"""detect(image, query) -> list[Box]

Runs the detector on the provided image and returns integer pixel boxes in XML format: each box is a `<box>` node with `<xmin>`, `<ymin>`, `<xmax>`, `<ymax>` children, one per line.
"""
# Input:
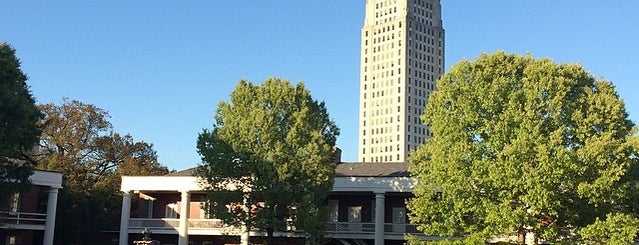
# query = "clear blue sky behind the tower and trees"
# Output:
<box><xmin>0</xmin><ymin>0</ymin><xmax>639</xmax><ymax>170</ymax></box>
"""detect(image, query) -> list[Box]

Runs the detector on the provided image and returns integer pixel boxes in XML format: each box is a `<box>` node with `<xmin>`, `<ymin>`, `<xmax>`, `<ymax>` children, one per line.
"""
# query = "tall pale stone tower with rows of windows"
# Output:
<box><xmin>358</xmin><ymin>0</ymin><xmax>444</xmax><ymax>162</ymax></box>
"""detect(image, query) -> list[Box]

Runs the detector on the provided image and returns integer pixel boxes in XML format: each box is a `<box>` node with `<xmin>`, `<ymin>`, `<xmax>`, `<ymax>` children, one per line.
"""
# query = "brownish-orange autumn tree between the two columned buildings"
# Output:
<box><xmin>29</xmin><ymin>99</ymin><xmax>168</xmax><ymax>244</ymax></box>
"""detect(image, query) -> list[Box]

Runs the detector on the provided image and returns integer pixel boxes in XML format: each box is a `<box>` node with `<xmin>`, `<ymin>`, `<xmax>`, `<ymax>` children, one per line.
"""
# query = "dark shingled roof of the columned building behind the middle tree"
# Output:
<box><xmin>166</xmin><ymin>162</ymin><xmax>409</xmax><ymax>177</ymax></box>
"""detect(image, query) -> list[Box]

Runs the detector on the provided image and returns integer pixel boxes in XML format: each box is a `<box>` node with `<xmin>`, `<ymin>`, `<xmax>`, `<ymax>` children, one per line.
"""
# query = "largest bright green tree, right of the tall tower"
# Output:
<box><xmin>408</xmin><ymin>52</ymin><xmax>639</xmax><ymax>244</ymax></box>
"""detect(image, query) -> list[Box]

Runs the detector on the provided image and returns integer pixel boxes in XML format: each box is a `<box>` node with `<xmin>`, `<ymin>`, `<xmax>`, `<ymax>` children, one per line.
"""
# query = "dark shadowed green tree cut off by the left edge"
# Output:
<box><xmin>0</xmin><ymin>43</ymin><xmax>41</xmax><ymax>211</ymax></box>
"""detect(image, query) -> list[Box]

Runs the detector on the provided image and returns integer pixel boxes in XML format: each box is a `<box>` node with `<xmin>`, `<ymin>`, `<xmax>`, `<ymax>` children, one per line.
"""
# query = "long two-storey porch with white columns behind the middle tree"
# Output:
<box><xmin>120</xmin><ymin>164</ymin><xmax>419</xmax><ymax>245</ymax></box>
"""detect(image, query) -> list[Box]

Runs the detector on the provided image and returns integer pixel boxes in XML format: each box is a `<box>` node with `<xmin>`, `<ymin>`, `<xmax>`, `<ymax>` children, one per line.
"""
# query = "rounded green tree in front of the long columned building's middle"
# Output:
<box><xmin>197</xmin><ymin>78</ymin><xmax>339</xmax><ymax>243</ymax></box>
